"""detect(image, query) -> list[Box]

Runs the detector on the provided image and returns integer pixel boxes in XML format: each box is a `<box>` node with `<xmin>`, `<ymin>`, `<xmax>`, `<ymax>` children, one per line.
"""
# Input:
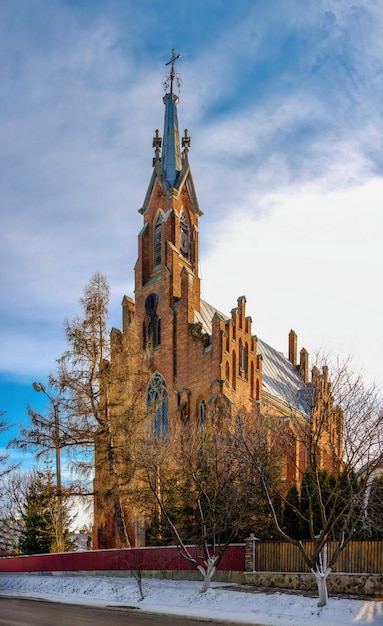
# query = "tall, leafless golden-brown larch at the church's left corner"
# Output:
<box><xmin>52</xmin><ymin>272</ymin><xmax>147</xmax><ymax>597</ymax></box>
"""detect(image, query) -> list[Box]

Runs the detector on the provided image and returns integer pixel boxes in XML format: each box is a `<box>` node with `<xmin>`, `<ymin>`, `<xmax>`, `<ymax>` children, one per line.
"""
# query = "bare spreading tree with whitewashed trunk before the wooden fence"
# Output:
<box><xmin>242</xmin><ymin>361</ymin><xmax>383</xmax><ymax>606</ymax></box>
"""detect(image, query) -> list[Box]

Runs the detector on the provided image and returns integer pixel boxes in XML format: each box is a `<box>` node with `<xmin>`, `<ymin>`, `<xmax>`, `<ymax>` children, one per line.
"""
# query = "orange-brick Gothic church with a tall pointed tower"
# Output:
<box><xmin>93</xmin><ymin>51</ymin><xmax>342</xmax><ymax>548</ymax></box>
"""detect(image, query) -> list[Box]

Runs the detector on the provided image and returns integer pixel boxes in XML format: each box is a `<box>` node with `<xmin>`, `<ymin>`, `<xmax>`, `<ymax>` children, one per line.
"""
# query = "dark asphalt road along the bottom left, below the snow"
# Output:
<box><xmin>0</xmin><ymin>597</ymin><xmax>243</xmax><ymax>626</ymax></box>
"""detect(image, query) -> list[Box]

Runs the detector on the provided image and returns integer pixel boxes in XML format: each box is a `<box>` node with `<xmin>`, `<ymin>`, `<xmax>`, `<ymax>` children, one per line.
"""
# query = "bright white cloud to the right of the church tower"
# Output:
<box><xmin>202</xmin><ymin>173</ymin><xmax>383</xmax><ymax>384</ymax></box>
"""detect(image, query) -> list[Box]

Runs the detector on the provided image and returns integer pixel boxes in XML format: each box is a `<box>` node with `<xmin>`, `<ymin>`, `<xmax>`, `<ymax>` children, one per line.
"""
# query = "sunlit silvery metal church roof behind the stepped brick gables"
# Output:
<box><xmin>194</xmin><ymin>300</ymin><xmax>314</xmax><ymax>416</ymax></box>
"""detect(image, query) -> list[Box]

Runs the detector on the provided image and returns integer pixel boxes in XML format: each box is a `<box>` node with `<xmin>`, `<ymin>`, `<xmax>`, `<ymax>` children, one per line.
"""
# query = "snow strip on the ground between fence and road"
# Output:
<box><xmin>0</xmin><ymin>574</ymin><xmax>383</xmax><ymax>626</ymax></box>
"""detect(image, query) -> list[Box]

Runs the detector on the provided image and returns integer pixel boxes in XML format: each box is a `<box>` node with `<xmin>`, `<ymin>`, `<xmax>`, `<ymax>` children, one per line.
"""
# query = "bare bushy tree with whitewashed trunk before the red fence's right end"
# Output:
<box><xmin>136</xmin><ymin>415</ymin><xmax>270</xmax><ymax>592</ymax></box>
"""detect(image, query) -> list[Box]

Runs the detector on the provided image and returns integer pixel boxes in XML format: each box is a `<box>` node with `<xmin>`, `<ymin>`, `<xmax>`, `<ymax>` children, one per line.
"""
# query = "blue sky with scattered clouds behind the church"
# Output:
<box><xmin>0</xmin><ymin>0</ymin><xmax>383</xmax><ymax>468</ymax></box>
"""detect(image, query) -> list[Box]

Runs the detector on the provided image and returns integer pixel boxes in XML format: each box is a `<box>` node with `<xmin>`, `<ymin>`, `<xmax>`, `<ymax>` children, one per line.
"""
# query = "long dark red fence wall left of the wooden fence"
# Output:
<box><xmin>0</xmin><ymin>544</ymin><xmax>245</xmax><ymax>572</ymax></box>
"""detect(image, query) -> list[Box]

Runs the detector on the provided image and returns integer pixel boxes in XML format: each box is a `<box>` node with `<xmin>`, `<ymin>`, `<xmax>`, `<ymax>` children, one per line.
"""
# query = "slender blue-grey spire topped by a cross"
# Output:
<box><xmin>162</xmin><ymin>49</ymin><xmax>182</xmax><ymax>187</ymax></box>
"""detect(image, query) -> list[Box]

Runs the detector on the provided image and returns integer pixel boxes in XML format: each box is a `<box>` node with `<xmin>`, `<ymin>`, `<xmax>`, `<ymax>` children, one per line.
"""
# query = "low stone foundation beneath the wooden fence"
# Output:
<box><xmin>244</xmin><ymin>572</ymin><xmax>383</xmax><ymax>598</ymax></box>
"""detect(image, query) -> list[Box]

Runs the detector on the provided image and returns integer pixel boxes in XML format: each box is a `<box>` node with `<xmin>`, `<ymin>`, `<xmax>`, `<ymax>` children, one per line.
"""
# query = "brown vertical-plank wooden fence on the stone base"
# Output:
<box><xmin>252</xmin><ymin>540</ymin><xmax>383</xmax><ymax>574</ymax></box>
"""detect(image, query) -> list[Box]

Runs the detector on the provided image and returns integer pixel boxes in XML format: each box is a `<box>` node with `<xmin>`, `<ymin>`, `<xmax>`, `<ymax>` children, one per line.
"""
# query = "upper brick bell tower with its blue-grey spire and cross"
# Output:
<box><xmin>135</xmin><ymin>50</ymin><xmax>202</xmax><ymax>354</ymax></box>
